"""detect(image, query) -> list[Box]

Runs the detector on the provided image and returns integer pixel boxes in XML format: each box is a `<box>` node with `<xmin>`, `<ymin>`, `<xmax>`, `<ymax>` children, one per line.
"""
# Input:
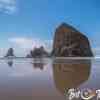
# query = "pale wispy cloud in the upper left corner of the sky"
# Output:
<box><xmin>0</xmin><ymin>0</ymin><xmax>17</xmax><ymax>14</ymax></box>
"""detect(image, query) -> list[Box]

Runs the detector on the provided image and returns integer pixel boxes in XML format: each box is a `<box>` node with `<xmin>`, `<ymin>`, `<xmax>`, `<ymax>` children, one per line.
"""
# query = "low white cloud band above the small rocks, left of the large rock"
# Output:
<box><xmin>8</xmin><ymin>37</ymin><xmax>52</xmax><ymax>49</ymax></box>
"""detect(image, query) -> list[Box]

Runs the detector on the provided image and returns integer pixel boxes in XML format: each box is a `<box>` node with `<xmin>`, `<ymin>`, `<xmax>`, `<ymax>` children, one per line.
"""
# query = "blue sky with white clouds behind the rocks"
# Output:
<box><xmin>0</xmin><ymin>0</ymin><xmax>100</xmax><ymax>56</ymax></box>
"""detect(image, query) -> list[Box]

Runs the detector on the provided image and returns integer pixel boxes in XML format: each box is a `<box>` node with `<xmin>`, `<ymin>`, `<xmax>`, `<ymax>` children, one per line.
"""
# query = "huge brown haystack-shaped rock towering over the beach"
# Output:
<box><xmin>52</xmin><ymin>23</ymin><xmax>93</xmax><ymax>57</ymax></box>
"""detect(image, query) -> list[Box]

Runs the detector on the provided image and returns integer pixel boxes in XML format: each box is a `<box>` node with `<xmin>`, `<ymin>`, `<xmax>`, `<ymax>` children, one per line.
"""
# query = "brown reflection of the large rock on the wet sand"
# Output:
<box><xmin>53</xmin><ymin>61</ymin><xmax>91</xmax><ymax>94</ymax></box>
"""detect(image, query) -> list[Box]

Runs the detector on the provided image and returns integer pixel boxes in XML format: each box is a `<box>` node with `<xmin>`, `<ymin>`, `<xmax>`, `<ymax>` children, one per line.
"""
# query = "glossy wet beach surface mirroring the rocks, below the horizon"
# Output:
<box><xmin>0</xmin><ymin>58</ymin><xmax>100</xmax><ymax>100</ymax></box>
